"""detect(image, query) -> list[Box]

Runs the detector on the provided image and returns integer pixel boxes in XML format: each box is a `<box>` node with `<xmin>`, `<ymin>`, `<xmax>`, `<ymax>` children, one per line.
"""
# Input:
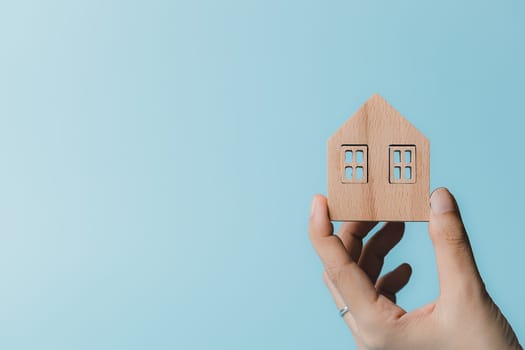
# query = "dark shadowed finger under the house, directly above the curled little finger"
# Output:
<box><xmin>359</xmin><ymin>222</ymin><xmax>405</xmax><ymax>284</ymax></box>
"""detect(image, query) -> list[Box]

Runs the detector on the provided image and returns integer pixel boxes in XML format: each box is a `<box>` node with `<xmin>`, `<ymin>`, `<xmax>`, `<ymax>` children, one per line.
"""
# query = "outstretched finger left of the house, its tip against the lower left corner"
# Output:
<box><xmin>310</xmin><ymin>195</ymin><xmax>377</xmax><ymax>317</ymax></box>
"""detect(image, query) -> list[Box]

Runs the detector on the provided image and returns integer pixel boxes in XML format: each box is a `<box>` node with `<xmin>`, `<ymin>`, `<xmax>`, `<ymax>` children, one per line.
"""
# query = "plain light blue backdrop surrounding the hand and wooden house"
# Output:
<box><xmin>0</xmin><ymin>0</ymin><xmax>525</xmax><ymax>349</ymax></box>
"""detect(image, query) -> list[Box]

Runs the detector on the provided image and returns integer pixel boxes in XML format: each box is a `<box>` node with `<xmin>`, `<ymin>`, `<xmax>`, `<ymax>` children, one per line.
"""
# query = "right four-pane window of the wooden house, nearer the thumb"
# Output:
<box><xmin>389</xmin><ymin>145</ymin><xmax>416</xmax><ymax>184</ymax></box>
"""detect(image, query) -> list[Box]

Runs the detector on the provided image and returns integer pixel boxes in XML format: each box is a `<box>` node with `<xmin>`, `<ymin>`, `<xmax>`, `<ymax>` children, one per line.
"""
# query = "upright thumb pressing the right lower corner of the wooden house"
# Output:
<box><xmin>429</xmin><ymin>188</ymin><xmax>483</xmax><ymax>296</ymax></box>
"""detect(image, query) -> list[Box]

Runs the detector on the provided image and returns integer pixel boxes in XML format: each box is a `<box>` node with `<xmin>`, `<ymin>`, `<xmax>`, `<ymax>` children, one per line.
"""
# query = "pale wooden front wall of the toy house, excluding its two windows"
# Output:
<box><xmin>328</xmin><ymin>95</ymin><xmax>430</xmax><ymax>221</ymax></box>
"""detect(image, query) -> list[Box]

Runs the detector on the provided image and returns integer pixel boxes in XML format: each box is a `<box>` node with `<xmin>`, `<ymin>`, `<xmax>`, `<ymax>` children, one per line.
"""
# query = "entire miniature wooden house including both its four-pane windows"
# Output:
<box><xmin>328</xmin><ymin>94</ymin><xmax>430</xmax><ymax>221</ymax></box>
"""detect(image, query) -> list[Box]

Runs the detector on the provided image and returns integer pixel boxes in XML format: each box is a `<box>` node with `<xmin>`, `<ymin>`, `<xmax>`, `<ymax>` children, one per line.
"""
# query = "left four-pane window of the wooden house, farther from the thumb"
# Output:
<box><xmin>341</xmin><ymin>145</ymin><xmax>368</xmax><ymax>183</ymax></box>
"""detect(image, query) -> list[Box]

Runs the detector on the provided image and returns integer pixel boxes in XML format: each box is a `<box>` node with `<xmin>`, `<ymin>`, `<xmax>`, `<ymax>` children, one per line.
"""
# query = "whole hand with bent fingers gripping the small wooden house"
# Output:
<box><xmin>309</xmin><ymin>188</ymin><xmax>522</xmax><ymax>350</ymax></box>
